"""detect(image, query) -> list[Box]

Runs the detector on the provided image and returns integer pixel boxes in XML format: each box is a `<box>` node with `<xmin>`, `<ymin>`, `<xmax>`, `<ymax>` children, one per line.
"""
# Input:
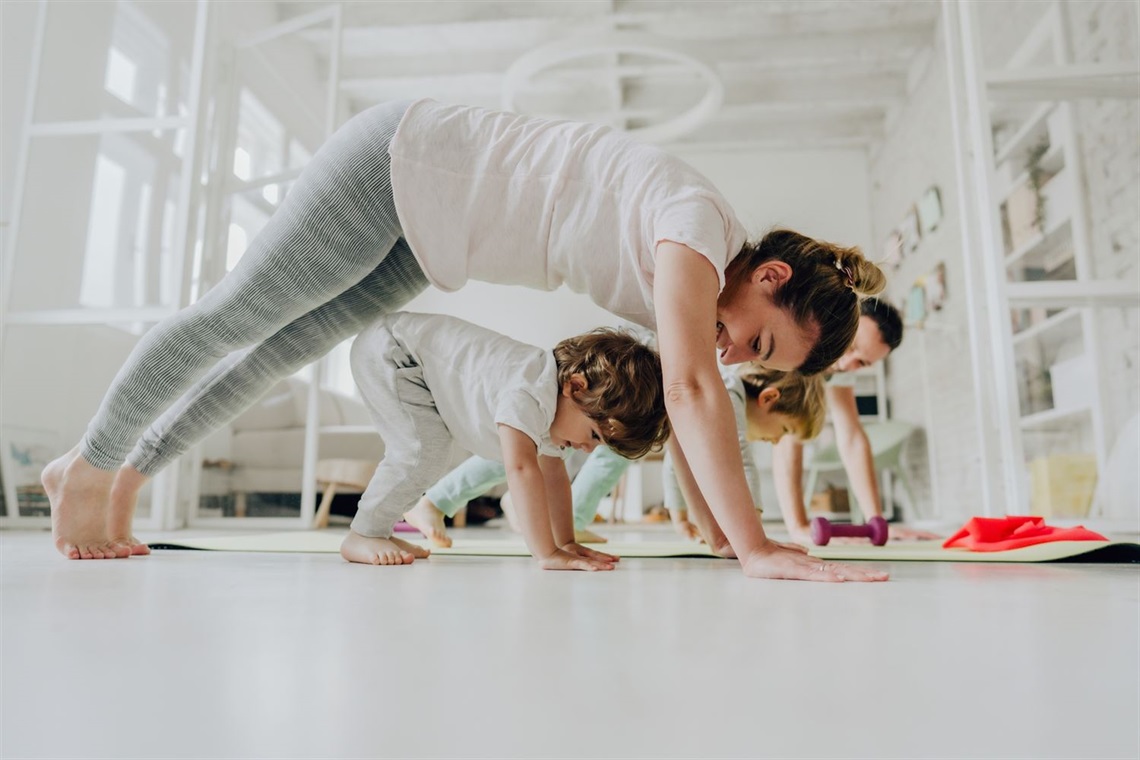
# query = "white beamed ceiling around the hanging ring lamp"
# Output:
<box><xmin>277</xmin><ymin>0</ymin><xmax>939</xmax><ymax>147</ymax></box>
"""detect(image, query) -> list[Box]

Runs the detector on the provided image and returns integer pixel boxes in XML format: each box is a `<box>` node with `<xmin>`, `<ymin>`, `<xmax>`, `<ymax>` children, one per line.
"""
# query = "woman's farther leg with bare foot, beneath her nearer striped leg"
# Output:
<box><xmin>107</xmin><ymin>238</ymin><xmax>428</xmax><ymax>554</ymax></box>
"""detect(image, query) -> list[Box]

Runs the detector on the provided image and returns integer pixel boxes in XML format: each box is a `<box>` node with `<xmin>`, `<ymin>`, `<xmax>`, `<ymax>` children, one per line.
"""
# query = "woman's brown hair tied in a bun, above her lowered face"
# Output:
<box><xmin>725</xmin><ymin>229</ymin><xmax>887</xmax><ymax>375</ymax></box>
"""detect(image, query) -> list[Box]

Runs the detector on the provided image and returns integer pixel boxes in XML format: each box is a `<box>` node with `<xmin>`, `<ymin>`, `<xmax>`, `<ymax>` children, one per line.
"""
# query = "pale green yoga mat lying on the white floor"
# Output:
<box><xmin>150</xmin><ymin>531</ymin><xmax>1140</xmax><ymax>563</ymax></box>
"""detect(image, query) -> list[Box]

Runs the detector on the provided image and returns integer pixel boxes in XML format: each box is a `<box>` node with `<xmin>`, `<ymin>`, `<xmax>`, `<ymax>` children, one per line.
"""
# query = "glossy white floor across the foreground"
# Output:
<box><xmin>0</xmin><ymin>528</ymin><xmax>1140</xmax><ymax>759</ymax></box>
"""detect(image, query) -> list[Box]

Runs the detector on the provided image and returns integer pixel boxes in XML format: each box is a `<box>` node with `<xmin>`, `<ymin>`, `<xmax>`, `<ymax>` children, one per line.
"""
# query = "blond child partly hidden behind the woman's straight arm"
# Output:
<box><xmin>661</xmin><ymin>365</ymin><xmax>824</xmax><ymax>538</ymax></box>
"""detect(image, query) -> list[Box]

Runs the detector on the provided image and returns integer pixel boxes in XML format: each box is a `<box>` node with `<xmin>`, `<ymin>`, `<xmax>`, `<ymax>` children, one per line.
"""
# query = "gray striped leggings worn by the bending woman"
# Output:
<box><xmin>81</xmin><ymin>103</ymin><xmax>428</xmax><ymax>475</ymax></box>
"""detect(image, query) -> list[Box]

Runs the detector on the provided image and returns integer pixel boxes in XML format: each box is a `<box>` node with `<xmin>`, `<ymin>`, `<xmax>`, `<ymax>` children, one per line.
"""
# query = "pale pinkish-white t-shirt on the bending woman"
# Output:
<box><xmin>389</xmin><ymin>100</ymin><xmax>747</xmax><ymax>329</ymax></box>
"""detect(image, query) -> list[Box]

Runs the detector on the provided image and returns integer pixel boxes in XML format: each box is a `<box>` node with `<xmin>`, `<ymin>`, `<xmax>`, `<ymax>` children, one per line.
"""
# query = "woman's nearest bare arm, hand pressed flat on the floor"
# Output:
<box><xmin>653</xmin><ymin>242</ymin><xmax>887</xmax><ymax>581</ymax></box>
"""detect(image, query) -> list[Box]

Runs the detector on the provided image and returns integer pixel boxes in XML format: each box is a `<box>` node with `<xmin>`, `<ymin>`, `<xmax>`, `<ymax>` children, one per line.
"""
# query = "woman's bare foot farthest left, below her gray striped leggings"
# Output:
<box><xmin>40</xmin><ymin>446</ymin><xmax>131</xmax><ymax>559</ymax></box>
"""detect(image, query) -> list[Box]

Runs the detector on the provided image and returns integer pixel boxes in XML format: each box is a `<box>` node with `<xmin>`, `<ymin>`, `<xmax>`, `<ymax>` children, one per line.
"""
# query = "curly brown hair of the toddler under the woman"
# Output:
<box><xmin>554</xmin><ymin>328</ymin><xmax>669</xmax><ymax>459</ymax></box>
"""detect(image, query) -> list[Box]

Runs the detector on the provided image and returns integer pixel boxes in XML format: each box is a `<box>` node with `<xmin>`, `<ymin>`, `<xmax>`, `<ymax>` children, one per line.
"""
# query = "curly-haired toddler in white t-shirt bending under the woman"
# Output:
<box><xmin>341</xmin><ymin>312</ymin><xmax>669</xmax><ymax>570</ymax></box>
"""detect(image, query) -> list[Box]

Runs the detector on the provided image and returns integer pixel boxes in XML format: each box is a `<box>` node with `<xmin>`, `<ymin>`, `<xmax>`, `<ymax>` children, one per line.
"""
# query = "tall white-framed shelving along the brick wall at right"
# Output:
<box><xmin>944</xmin><ymin>1</ymin><xmax>1140</xmax><ymax>516</ymax></box>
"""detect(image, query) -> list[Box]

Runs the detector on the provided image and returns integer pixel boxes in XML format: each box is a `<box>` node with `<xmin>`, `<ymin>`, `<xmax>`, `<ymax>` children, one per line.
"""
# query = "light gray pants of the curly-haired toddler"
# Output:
<box><xmin>351</xmin><ymin>324</ymin><xmax>451</xmax><ymax>538</ymax></box>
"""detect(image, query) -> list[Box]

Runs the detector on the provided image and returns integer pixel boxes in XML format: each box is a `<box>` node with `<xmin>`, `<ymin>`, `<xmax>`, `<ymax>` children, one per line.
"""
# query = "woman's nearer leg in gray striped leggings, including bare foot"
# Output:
<box><xmin>43</xmin><ymin>104</ymin><xmax>414</xmax><ymax>558</ymax></box>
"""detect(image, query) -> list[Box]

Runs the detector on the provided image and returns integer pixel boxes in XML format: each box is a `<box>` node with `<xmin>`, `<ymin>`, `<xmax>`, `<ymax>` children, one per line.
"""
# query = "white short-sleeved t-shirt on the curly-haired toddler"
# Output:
<box><xmin>381</xmin><ymin>311</ymin><xmax>564</xmax><ymax>461</ymax></box>
